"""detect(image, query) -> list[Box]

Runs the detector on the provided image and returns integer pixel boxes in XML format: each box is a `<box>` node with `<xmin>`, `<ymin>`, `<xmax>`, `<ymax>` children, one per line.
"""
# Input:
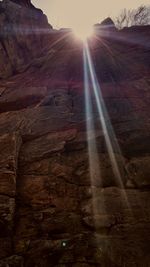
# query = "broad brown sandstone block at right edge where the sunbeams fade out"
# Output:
<box><xmin>83</xmin><ymin>187</ymin><xmax>149</xmax><ymax>228</ymax></box>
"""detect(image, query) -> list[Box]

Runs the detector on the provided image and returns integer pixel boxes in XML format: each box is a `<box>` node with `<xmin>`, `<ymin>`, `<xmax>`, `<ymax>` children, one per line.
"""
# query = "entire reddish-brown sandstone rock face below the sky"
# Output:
<box><xmin>0</xmin><ymin>0</ymin><xmax>150</xmax><ymax>267</ymax></box>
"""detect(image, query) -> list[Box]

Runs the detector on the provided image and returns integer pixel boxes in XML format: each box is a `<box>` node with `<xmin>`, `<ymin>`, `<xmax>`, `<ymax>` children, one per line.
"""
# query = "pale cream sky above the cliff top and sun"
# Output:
<box><xmin>32</xmin><ymin>0</ymin><xmax>149</xmax><ymax>29</ymax></box>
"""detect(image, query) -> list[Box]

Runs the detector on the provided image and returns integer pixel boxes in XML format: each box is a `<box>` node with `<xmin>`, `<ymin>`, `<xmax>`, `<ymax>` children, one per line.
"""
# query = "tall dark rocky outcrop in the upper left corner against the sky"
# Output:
<box><xmin>0</xmin><ymin>0</ymin><xmax>51</xmax><ymax>78</ymax></box>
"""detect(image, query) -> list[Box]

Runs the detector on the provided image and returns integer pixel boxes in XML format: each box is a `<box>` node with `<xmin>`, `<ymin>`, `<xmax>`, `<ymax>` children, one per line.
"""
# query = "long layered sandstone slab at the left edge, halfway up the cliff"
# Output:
<box><xmin>0</xmin><ymin>107</ymin><xmax>74</xmax><ymax>140</ymax></box>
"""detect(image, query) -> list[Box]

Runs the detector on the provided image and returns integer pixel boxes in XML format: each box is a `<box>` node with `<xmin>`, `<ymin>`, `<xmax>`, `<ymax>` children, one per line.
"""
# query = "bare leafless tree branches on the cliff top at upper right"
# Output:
<box><xmin>115</xmin><ymin>5</ymin><xmax>150</xmax><ymax>29</ymax></box>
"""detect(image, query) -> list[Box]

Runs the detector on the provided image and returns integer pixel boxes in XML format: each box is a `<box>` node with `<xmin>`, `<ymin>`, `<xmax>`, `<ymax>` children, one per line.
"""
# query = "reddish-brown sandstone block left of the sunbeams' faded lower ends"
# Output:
<box><xmin>18</xmin><ymin>175</ymin><xmax>78</xmax><ymax>210</ymax></box>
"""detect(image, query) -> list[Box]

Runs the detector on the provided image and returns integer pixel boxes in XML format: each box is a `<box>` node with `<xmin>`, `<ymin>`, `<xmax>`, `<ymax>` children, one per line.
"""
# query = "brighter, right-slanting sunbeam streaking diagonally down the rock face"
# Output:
<box><xmin>85</xmin><ymin>42</ymin><xmax>130</xmax><ymax>207</ymax></box>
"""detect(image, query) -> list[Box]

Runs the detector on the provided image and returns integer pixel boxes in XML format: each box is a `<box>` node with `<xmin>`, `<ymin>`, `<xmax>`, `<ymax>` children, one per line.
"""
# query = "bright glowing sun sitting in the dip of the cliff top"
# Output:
<box><xmin>72</xmin><ymin>25</ymin><xmax>94</xmax><ymax>42</ymax></box>
